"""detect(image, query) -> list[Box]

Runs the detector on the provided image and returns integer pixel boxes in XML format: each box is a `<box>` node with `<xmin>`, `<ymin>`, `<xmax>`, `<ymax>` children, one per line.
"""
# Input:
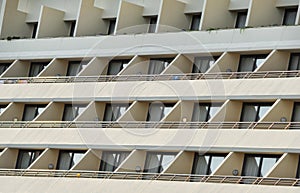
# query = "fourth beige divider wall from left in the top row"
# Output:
<box><xmin>116</xmin><ymin>1</ymin><xmax>148</xmax><ymax>34</ymax></box>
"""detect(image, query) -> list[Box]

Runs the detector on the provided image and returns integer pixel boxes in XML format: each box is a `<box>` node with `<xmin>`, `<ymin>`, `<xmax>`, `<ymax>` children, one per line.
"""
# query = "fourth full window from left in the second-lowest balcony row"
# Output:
<box><xmin>147</xmin><ymin>103</ymin><xmax>174</xmax><ymax>121</ymax></box>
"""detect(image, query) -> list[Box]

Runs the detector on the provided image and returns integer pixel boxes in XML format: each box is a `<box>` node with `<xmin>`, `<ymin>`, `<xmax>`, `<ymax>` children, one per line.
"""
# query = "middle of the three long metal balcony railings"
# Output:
<box><xmin>0</xmin><ymin>121</ymin><xmax>300</xmax><ymax>130</ymax></box>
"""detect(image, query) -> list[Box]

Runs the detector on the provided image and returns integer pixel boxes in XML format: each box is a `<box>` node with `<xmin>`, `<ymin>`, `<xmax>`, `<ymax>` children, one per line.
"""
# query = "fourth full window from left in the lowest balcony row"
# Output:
<box><xmin>144</xmin><ymin>152</ymin><xmax>176</xmax><ymax>173</ymax></box>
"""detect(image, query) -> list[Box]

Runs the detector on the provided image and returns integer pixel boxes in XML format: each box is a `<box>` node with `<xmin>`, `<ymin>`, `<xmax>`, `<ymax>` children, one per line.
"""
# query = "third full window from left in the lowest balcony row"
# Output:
<box><xmin>99</xmin><ymin>152</ymin><xmax>129</xmax><ymax>172</ymax></box>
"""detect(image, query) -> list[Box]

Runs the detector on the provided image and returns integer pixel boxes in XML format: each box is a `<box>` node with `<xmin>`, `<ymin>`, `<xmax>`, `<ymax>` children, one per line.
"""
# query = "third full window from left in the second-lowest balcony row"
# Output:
<box><xmin>103</xmin><ymin>103</ymin><xmax>130</xmax><ymax>121</ymax></box>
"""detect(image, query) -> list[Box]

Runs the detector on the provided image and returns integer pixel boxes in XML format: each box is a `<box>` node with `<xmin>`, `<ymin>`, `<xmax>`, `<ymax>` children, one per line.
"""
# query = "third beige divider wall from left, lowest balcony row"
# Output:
<box><xmin>71</xmin><ymin>149</ymin><xmax>102</xmax><ymax>171</ymax></box>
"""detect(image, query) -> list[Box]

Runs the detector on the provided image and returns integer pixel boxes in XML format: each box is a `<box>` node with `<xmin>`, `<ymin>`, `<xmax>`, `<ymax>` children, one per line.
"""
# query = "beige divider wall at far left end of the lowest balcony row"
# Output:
<box><xmin>0</xmin><ymin>148</ymin><xmax>19</xmax><ymax>169</ymax></box>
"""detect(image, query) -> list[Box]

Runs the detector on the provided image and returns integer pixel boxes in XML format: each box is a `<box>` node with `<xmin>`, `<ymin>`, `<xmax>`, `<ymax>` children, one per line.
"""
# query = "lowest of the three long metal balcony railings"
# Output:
<box><xmin>0</xmin><ymin>169</ymin><xmax>300</xmax><ymax>186</ymax></box>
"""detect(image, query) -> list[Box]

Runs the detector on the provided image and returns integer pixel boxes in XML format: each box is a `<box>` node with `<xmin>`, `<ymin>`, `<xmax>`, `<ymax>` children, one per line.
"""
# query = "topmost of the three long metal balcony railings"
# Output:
<box><xmin>0</xmin><ymin>71</ymin><xmax>300</xmax><ymax>84</ymax></box>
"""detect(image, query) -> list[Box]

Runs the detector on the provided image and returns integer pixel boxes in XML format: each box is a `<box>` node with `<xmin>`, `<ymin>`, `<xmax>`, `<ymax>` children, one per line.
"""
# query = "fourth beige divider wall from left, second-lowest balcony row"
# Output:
<box><xmin>118</xmin><ymin>101</ymin><xmax>149</xmax><ymax>121</ymax></box>
